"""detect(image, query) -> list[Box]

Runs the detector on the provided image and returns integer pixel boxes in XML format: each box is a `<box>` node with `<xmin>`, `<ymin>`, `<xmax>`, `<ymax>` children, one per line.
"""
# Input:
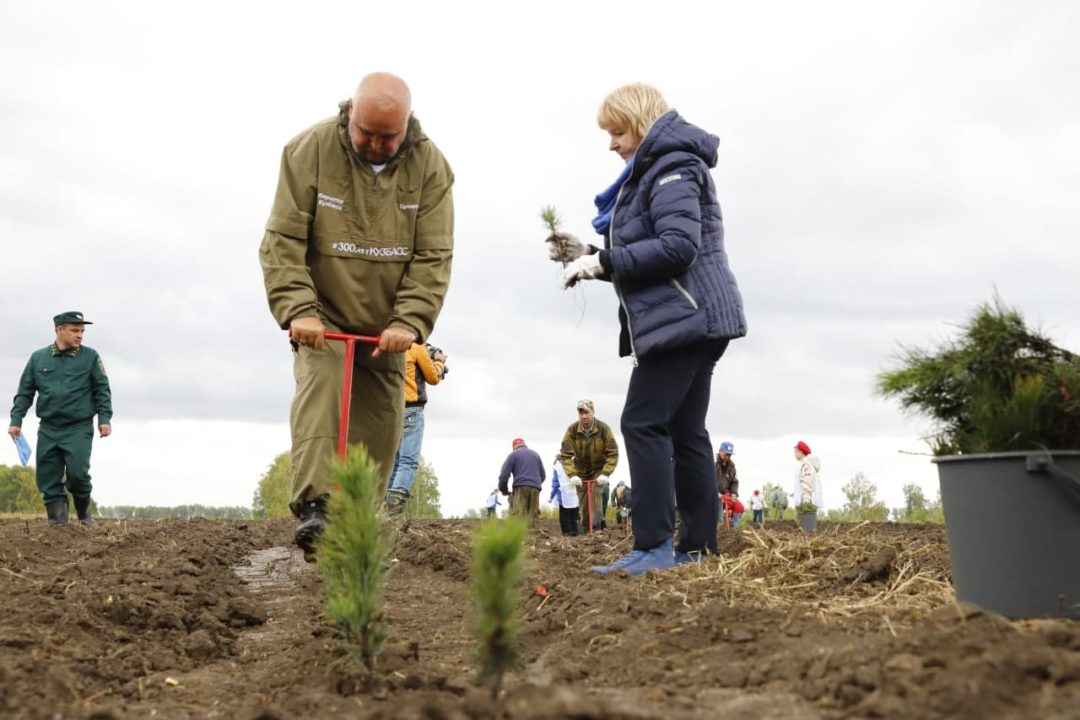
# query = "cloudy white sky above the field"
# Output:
<box><xmin>0</xmin><ymin>0</ymin><xmax>1080</xmax><ymax>514</ymax></box>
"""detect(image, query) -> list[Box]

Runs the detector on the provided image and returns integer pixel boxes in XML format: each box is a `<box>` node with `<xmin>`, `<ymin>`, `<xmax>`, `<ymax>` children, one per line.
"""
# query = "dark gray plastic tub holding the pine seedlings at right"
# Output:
<box><xmin>933</xmin><ymin>450</ymin><xmax>1080</xmax><ymax>620</ymax></box>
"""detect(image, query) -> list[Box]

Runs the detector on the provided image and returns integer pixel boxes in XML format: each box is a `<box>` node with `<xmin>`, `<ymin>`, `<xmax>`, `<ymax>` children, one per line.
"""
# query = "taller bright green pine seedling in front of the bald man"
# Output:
<box><xmin>315</xmin><ymin>447</ymin><xmax>389</xmax><ymax>680</ymax></box>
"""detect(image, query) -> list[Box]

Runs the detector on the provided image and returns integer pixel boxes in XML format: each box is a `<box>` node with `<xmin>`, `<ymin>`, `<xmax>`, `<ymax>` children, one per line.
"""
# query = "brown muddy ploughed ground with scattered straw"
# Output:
<box><xmin>0</xmin><ymin>519</ymin><xmax>1080</xmax><ymax>720</ymax></box>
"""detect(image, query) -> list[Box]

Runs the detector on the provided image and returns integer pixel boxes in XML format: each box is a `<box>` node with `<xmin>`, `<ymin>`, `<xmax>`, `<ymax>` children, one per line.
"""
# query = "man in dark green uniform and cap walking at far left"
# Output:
<box><xmin>8</xmin><ymin>311</ymin><xmax>112</xmax><ymax>526</ymax></box>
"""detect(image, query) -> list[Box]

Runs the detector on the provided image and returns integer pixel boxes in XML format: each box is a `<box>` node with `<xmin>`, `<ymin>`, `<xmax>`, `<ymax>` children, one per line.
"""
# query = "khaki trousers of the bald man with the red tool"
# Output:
<box><xmin>289</xmin><ymin>341</ymin><xmax>405</xmax><ymax>515</ymax></box>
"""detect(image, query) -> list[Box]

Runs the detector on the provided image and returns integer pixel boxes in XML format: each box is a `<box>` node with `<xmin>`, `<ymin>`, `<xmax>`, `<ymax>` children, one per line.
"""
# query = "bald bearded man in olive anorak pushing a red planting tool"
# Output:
<box><xmin>259</xmin><ymin>72</ymin><xmax>454</xmax><ymax>554</ymax></box>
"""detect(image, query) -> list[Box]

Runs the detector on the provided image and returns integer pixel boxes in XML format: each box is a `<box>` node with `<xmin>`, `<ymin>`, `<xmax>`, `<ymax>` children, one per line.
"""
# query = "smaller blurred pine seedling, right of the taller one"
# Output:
<box><xmin>472</xmin><ymin>518</ymin><xmax>527</xmax><ymax>699</ymax></box>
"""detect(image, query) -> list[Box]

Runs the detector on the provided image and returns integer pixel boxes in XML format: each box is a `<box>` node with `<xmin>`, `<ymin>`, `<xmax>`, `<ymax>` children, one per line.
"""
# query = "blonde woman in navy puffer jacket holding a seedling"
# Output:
<box><xmin>563</xmin><ymin>84</ymin><xmax>746</xmax><ymax>575</ymax></box>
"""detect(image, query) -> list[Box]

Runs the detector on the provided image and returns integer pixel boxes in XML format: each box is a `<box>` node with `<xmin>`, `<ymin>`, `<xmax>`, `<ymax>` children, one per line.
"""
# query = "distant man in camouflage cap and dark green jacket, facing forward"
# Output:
<box><xmin>559</xmin><ymin>400</ymin><xmax>619</xmax><ymax>532</ymax></box>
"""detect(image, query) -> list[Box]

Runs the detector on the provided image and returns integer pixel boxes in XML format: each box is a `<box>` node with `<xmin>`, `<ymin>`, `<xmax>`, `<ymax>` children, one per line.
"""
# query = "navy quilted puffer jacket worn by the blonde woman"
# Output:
<box><xmin>600</xmin><ymin>110</ymin><xmax>746</xmax><ymax>357</ymax></box>
